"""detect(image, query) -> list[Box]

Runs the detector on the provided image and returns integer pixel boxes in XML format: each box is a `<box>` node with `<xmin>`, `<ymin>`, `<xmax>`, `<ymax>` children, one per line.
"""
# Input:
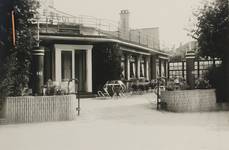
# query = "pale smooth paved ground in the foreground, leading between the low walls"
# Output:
<box><xmin>0</xmin><ymin>94</ymin><xmax>229</xmax><ymax>150</ymax></box>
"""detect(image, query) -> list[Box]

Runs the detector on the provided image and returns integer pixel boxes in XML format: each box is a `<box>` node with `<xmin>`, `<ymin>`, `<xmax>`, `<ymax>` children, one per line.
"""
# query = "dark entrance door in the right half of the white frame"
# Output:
<box><xmin>75</xmin><ymin>50</ymin><xmax>86</xmax><ymax>92</ymax></box>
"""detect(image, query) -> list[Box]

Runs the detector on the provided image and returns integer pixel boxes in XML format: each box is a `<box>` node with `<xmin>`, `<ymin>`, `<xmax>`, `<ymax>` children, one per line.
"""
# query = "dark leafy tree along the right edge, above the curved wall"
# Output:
<box><xmin>192</xmin><ymin>0</ymin><xmax>229</xmax><ymax>101</ymax></box>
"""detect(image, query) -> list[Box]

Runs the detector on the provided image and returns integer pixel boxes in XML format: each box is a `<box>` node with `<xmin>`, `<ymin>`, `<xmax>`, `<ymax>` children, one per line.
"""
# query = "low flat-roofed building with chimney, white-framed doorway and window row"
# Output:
<box><xmin>33</xmin><ymin>6</ymin><xmax>168</xmax><ymax>93</ymax></box>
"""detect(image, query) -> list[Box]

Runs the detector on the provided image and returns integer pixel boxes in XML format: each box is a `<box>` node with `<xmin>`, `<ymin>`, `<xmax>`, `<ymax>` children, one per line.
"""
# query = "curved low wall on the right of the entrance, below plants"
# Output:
<box><xmin>161</xmin><ymin>89</ymin><xmax>229</xmax><ymax>112</ymax></box>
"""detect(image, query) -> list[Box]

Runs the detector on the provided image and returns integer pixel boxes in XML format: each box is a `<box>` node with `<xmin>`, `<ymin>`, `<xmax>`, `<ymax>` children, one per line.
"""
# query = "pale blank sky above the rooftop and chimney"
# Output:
<box><xmin>44</xmin><ymin>0</ymin><xmax>212</xmax><ymax>48</ymax></box>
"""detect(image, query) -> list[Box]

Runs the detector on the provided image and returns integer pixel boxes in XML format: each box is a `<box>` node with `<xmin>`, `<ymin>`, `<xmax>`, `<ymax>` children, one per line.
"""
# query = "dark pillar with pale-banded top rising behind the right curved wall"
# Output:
<box><xmin>185</xmin><ymin>51</ymin><xmax>195</xmax><ymax>89</ymax></box>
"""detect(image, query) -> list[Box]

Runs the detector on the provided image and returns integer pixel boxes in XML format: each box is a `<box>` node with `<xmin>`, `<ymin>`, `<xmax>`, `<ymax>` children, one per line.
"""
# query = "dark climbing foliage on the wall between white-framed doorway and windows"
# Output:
<box><xmin>93</xmin><ymin>43</ymin><xmax>122</xmax><ymax>91</ymax></box>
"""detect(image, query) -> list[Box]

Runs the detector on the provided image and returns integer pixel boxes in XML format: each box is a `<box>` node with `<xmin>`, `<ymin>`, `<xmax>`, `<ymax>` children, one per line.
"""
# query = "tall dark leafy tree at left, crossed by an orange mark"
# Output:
<box><xmin>0</xmin><ymin>0</ymin><xmax>39</xmax><ymax>96</ymax></box>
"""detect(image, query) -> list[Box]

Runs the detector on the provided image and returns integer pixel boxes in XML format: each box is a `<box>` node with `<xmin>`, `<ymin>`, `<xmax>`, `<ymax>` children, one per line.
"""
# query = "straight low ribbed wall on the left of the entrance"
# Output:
<box><xmin>3</xmin><ymin>95</ymin><xmax>77</xmax><ymax>123</ymax></box>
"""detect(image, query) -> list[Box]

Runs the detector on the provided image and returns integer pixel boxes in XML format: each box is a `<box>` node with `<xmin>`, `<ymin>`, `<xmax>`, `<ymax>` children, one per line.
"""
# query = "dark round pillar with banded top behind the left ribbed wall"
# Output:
<box><xmin>32</xmin><ymin>47</ymin><xmax>44</xmax><ymax>95</ymax></box>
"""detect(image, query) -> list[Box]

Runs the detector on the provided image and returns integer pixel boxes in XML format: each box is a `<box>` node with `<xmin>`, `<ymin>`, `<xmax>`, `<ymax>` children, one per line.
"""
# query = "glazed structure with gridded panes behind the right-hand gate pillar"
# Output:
<box><xmin>168</xmin><ymin>41</ymin><xmax>222</xmax><ymax>83</ymax></box>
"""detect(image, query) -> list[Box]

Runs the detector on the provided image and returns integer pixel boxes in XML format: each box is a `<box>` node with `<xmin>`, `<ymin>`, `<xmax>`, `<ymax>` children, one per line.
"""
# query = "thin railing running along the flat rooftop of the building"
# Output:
<box><xmin>36</xmin><ymin>13</ymin><xmax>159</xmax><ymax>50</ymax></box>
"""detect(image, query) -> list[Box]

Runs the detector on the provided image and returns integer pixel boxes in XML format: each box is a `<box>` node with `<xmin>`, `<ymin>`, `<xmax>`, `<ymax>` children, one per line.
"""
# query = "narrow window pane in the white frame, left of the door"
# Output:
<box><xmin>61</xmin><ymin>51</ymin><xmax>72</xmax><ymax>80</ymax></box>
